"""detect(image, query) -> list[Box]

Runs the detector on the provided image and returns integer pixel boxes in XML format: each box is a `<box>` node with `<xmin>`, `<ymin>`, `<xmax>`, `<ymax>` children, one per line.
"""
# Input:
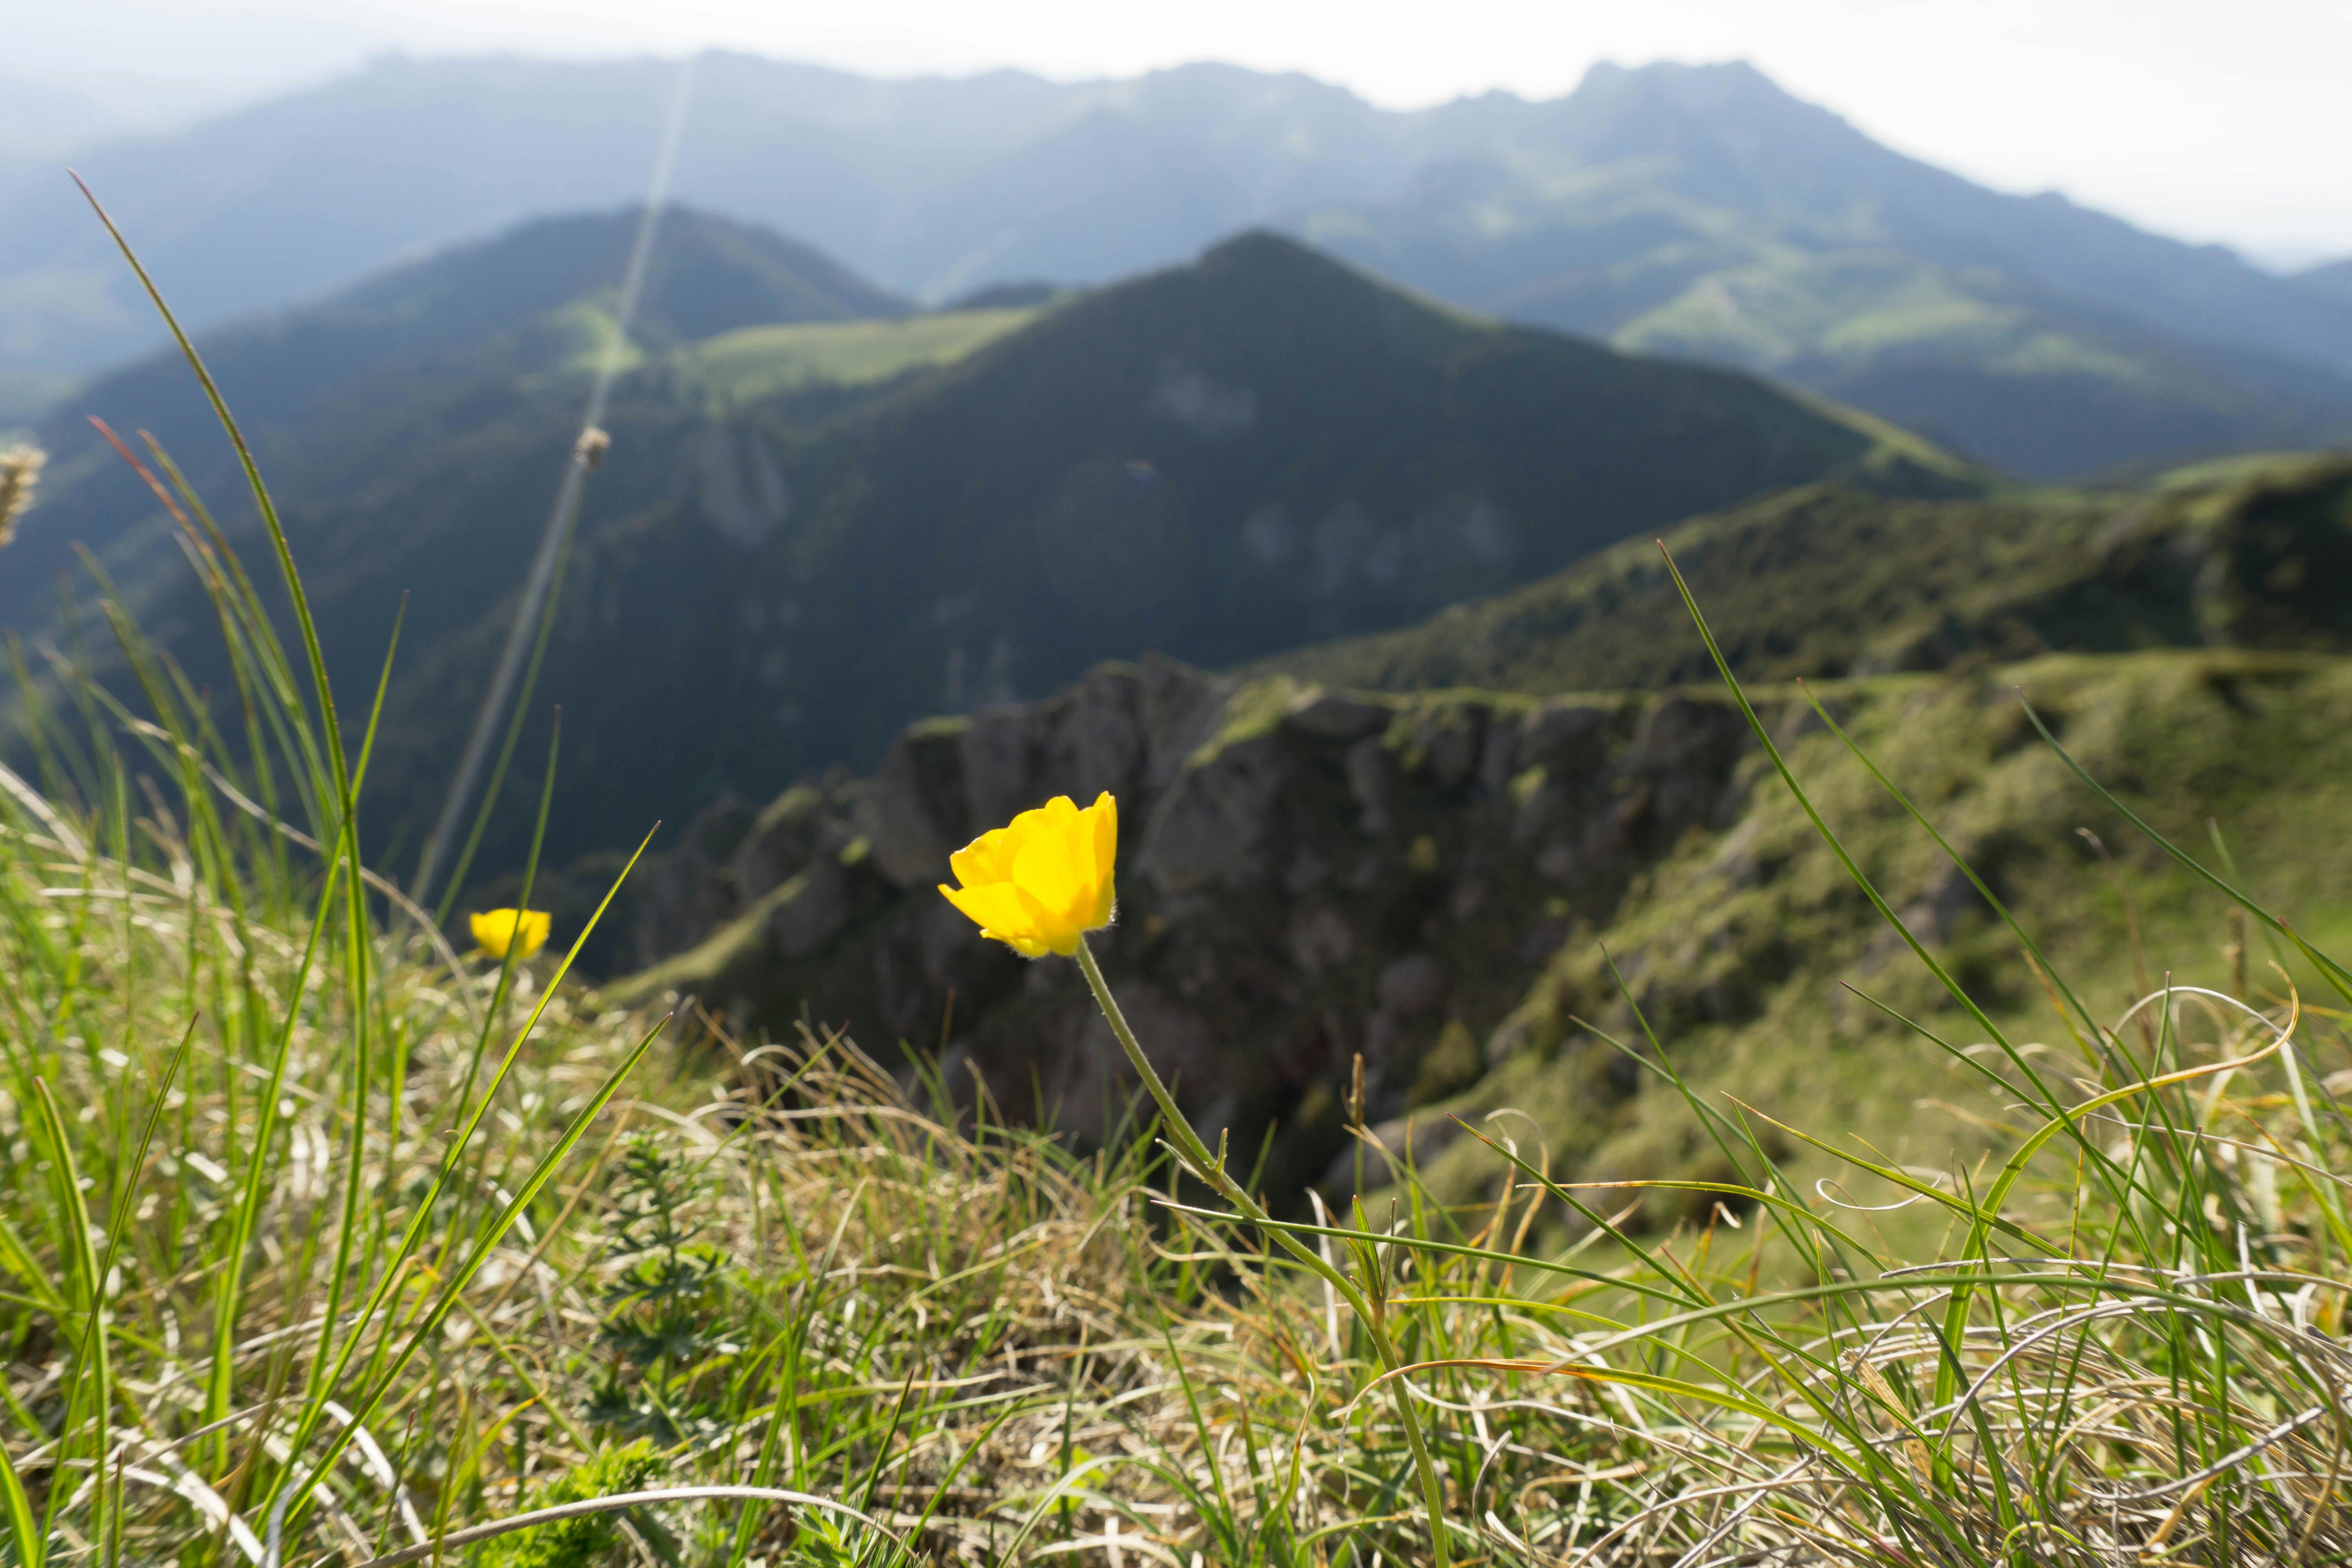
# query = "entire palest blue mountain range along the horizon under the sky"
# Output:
<box><xmin>14</xmin><ymin>54</ymin><xmax>2352</xmax><ymax>475</ymax></box>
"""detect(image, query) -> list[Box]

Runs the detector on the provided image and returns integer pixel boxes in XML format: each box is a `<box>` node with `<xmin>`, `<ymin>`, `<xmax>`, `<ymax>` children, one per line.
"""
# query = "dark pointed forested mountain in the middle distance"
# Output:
<box><xmin>358</xmin><ymin>235</ymin><xmax>1983</xmax><ymax>879</ymax></box>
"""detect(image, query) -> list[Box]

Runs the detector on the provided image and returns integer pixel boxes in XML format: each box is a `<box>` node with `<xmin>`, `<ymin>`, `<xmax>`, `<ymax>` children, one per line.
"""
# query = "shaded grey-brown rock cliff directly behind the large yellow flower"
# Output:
<box><xmin>614</xmin><ymin>663</ymin><xmax>1748</xmax><ymax>1189</ymax></box>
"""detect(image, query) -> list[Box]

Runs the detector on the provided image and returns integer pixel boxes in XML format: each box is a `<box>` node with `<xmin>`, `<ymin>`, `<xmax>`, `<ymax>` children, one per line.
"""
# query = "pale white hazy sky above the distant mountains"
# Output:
<box><xmin>14</xmin><ymin>0</ymin><xmax>2352</xmax><ymax>261</ymax></box>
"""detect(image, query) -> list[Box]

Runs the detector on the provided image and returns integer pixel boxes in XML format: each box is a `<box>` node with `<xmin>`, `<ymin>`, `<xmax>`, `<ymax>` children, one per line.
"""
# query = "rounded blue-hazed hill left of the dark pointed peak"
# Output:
<box><xmin>0</xmin><ymin>209</ymin><xmax>908</xmax><ymax>639</ymax></box>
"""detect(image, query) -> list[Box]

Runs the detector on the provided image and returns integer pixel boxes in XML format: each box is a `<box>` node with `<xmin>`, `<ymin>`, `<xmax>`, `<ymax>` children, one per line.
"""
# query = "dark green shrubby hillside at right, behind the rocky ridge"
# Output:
<box><xmin>1268</xmin><ymin>456</ymin><xmax>2352</xmax><ymax>691</ymax></box>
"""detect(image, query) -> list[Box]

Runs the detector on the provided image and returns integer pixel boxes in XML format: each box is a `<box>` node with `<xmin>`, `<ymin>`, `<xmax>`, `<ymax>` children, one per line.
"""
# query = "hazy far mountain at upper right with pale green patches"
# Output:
<box><xmin>1303</xmin><ymin>64</ymin><xmax>2352</xmax><ymax>477</ymax></box>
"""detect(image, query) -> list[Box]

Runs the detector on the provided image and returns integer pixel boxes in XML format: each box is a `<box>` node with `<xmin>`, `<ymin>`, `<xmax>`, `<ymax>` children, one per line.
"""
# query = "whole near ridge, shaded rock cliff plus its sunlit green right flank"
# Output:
<box><xmin>593</xmin><ymin>649</ymin><xmax>2352</xmax><ymax>1232</ymax></box>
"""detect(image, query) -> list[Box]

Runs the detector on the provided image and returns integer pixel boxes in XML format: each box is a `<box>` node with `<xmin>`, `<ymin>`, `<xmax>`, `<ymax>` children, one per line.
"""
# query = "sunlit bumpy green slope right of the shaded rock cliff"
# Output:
<box><xmin>1425</xmin><ymin>651</ymin><xmax>2352</xmax><ymax>1222</ymax></box>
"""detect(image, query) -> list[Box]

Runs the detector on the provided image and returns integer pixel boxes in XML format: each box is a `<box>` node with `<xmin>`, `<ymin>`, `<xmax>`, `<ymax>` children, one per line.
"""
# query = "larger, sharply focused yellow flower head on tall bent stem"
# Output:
<box><xmin>938</xmin><ymin>790</ymin><xmax>1120</xmax><ymax>959</ymax></box>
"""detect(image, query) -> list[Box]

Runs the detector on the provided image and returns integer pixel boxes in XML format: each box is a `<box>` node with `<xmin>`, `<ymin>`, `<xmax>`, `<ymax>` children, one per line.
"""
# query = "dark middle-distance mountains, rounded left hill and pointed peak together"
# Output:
<box><xmin>14</xmin><ymin>209</ymin><xmax>1983</xmax><ymax>865</ymax></box>
